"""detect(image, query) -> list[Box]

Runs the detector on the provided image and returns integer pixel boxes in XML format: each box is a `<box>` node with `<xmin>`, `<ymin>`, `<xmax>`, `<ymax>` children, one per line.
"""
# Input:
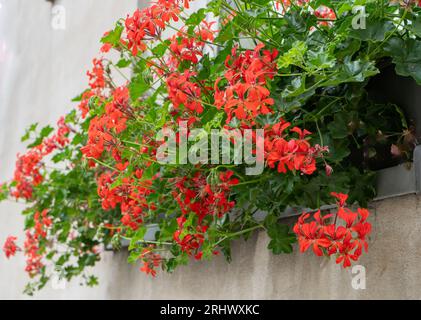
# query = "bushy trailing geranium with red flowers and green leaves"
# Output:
<box><xmin>0</xmin><ymin>0</ymin><xmax>421</xmax><ymax>294</ymax></box>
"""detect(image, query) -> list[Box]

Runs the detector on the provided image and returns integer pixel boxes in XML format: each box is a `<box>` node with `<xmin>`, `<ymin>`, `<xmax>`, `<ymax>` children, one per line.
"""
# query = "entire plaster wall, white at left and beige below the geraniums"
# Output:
<box><xmin>0</xmin><ymin>0</ymin><xmax>421</xmax><ymax>299</ymax></box>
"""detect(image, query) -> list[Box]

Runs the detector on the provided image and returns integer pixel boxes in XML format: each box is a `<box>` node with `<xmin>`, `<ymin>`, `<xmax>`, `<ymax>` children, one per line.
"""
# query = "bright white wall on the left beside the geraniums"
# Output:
<box><xmin>0</xmin><ymin>0</ymin><xmax>137</xmax><ymax>298</ymax></box>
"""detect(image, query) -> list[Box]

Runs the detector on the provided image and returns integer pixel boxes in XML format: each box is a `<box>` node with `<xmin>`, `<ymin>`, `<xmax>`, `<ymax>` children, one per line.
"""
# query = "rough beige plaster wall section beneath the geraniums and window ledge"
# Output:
<box><xmin>92</xmin><ymin>195</ymin><xmax>421</xmax><ymax>299</ymax></box>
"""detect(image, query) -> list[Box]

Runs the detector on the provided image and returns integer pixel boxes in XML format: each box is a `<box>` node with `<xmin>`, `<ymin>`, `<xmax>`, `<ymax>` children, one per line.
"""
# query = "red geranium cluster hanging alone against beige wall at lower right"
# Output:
<box><xmin>293</xmin><ymin>192</ymin><xmax>371</xmax><ymax>268</ymax></box>
